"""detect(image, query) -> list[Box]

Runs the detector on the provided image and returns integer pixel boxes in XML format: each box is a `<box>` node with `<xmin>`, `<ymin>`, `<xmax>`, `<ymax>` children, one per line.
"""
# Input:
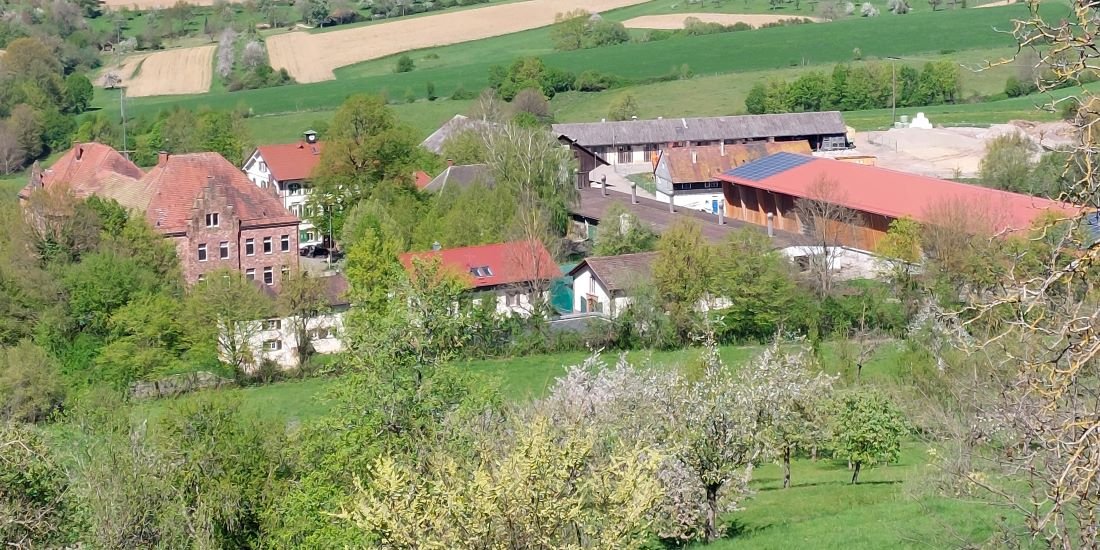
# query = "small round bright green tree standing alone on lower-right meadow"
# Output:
<box><xmin>833</xmin><ymin>391</ymin><xmax>909</xmax><ymax>484</ymax></box>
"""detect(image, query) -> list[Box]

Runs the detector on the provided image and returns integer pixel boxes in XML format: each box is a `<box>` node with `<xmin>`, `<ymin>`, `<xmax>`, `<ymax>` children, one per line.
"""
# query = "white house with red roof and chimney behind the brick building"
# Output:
<box><xmin>243</xmin><ymin>131</ymin><xmax>325</xmax><ymax>246</ymax></box>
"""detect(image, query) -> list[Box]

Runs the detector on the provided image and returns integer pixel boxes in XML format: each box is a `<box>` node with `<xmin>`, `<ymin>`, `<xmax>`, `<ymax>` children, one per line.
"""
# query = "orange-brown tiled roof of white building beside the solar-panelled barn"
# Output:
<box><xmin>659</xmin><ymin>140</ymin><xmax>813</xmax><ymax>184</ymax></box>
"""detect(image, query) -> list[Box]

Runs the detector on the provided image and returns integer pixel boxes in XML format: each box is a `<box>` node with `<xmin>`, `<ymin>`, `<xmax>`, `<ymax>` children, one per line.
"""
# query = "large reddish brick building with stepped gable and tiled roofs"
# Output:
<box><xmin>20</xmin><ymin>143</ymin><xmax>298</xmax><ymax>289</ymax></box>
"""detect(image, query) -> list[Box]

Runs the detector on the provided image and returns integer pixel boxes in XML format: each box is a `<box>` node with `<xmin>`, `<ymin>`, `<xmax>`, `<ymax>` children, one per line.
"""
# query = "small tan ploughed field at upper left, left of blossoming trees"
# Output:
<box><xmin>104</xmin><ymin>44</ymin><xmax>217</xmax><ymax>98</ymax></box>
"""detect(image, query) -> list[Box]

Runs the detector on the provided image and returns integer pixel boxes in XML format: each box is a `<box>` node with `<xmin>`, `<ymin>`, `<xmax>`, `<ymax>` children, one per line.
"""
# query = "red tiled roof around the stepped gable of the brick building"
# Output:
<box><xmin>142</xmin><ymin>153</ymin><xmax>298</xmax><ymax>233</ymax></box>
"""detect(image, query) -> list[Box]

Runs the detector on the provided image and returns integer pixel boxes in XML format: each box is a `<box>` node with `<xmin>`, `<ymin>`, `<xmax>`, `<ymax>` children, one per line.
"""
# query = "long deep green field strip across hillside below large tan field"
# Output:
<box><xmin>97</xmin><ymin>6</ymin><xmax>1062</xmax><ymax>122</ymax></box>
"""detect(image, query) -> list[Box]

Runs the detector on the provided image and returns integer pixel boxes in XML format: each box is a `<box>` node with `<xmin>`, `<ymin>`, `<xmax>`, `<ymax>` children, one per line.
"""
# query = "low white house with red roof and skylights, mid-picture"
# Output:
<box><xmin>398</xmin><ymin>241</ymin><xmax>561</xmax><ymax>315</ymax></box>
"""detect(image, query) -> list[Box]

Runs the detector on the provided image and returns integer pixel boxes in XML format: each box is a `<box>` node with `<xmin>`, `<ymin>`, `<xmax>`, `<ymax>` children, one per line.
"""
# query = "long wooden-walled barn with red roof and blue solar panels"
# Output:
<box><xmin>718</xmin><ymin>153</ymin><xmax>1077</xmax><ymax>251</ymax></box>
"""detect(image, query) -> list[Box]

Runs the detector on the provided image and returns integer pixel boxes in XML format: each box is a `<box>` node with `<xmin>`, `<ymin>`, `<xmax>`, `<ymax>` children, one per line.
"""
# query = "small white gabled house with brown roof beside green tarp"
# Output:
<box><xmin>569</xmin><ymin>252</ymin><xmax>657</xmax><ymax>318</ymax></box>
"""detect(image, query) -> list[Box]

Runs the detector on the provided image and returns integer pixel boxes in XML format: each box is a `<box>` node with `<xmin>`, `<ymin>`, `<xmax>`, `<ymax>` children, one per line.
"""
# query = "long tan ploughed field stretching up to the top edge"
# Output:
<box><xmin>267</xmin><ymin>0</ymin><xmax>646</xmax><ymax>83</ymax></box>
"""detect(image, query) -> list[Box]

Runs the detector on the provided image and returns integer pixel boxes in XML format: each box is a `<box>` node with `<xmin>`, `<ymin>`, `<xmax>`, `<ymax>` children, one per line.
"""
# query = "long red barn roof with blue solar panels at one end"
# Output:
<box><xmin>719</xmin><ymin>153</ymin><xmax>1078</xmax><ymax>232</ymax></box>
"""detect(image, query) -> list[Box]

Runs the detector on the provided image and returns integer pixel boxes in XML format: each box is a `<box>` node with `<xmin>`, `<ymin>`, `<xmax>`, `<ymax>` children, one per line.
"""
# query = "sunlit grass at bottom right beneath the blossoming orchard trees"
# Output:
<box><xmin>699</xmin><ymin>443</ymin><xmax>1001</xmax><ymax>550</ymax></box>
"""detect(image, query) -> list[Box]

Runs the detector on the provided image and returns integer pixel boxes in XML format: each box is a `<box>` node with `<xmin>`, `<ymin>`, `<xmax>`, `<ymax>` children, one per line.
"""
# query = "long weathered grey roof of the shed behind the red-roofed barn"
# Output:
<box><xmin>553</xmin><ymin>111</ymin><xmax>847</xmax><ymax>147</ymax></box>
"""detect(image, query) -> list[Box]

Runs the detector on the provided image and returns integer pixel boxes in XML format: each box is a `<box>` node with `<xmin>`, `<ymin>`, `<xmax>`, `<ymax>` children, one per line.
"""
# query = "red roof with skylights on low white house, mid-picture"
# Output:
<box><xmin>399</xmin><ymin>241</ymin><xmax>561</xmax><ymax>288</ymax></box>
